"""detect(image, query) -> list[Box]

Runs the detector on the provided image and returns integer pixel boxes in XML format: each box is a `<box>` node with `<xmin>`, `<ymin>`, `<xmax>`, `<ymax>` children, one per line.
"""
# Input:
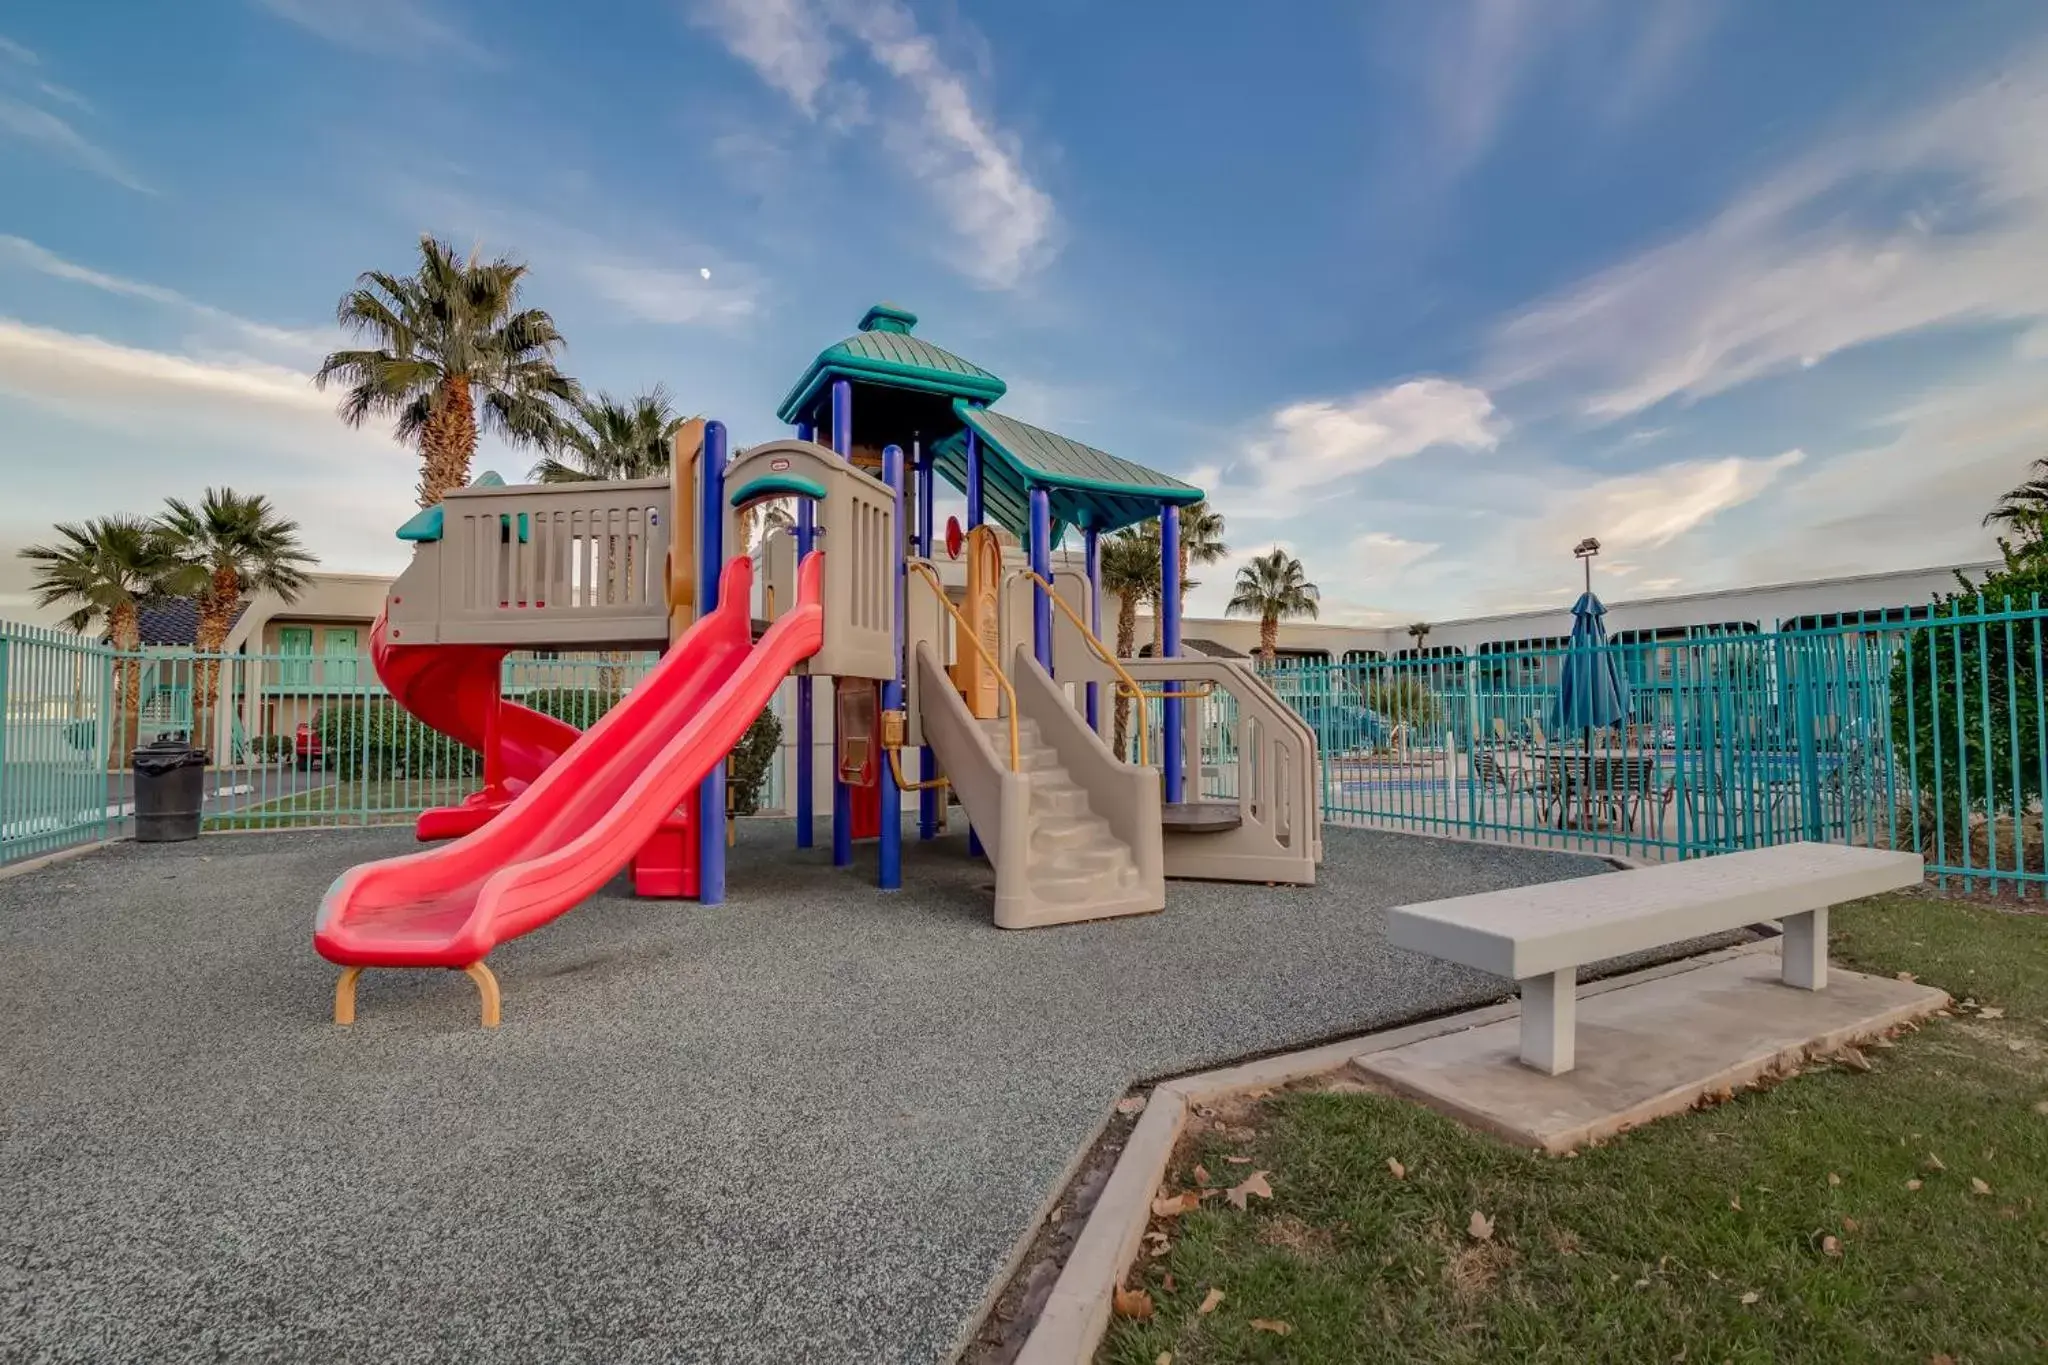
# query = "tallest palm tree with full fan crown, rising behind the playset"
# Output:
<box><xmin>313</xmin><ymin>237</ymin><xmax>582</xmax><ymax>508</ymax></box>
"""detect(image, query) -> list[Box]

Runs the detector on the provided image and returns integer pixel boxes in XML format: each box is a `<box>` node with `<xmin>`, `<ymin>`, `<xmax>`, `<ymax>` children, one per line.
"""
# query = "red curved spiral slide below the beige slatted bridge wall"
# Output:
<box><xmin>371</xmin><ymin>616</ymin><xmax>582</xmax><ymax>839</ymax></box>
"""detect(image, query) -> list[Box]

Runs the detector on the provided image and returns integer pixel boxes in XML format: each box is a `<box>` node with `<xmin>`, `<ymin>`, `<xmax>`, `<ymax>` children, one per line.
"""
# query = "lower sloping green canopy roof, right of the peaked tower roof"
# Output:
<box><xmin>932</xmin><ymin>401</ymin><xmax>1202</xmax><ymax>544</ymax></box>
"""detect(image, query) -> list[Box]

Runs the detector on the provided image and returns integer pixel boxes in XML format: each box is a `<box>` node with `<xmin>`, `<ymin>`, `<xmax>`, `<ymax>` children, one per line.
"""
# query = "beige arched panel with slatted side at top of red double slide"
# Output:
<box><xmin>725</xmin><ymin>440</ymin><xmax>901</xmax><ymax>677</ymax></box>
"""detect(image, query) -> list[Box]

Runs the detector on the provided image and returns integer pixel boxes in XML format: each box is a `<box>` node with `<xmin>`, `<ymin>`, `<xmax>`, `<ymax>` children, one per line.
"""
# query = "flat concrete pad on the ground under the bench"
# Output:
<box><xmin>1354</xmin><ymin>954</ymin><xmax>1948</xmax><ymax>1152</ymax></box>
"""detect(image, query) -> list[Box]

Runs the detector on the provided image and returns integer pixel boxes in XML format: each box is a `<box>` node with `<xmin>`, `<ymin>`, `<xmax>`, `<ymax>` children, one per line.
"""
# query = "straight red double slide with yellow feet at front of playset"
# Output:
<box><xmin>313</xmin><ymin>553</ymin><xmax>825</xmax><ymax>968</ymax></box>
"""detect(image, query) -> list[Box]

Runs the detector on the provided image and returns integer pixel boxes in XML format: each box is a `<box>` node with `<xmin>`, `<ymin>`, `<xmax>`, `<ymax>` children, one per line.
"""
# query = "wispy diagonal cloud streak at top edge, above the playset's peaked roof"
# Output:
<box><xmin>696</xmin><ymin>0</ymin><xmax>1059</xmax><ymax>289</ymax></box>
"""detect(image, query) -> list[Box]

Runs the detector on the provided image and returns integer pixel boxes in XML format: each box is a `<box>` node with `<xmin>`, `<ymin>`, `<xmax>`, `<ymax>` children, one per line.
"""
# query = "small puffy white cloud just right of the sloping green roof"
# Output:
<box><xmin>1229</xmin><ymin>379</ymin><xmax>1505</xmax><ymax>508</ymax></box>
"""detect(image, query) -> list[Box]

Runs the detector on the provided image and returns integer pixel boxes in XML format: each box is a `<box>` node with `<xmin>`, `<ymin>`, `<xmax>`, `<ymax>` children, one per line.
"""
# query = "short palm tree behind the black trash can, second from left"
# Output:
<box><xmin>160</xmin><ymin>489</ymin><xmax>315</xmax><ymax>757</ymax></box>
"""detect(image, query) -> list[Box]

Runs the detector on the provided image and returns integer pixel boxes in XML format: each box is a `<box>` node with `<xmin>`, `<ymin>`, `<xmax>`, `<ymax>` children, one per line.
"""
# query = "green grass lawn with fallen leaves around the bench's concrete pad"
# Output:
<box><xmin>1098</xmin><ymin>896</ymin><xmax>2048</xmax><ymax>1365</ymax></box>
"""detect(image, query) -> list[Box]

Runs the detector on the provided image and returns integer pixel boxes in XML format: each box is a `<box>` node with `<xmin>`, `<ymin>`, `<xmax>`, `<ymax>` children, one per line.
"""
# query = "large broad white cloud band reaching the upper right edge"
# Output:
<box><xmin>1491</xmin><ymin>53</ymin><xmax>2048</xmax><ymax>417</ymax></box>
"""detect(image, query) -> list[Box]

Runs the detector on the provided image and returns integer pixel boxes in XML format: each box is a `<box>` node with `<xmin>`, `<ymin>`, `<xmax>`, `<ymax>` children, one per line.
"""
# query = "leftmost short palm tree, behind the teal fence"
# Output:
<box><xmin>18</xmin><ymin>516</ymin><xmax>184</xmax><ymax>761</ymax></box>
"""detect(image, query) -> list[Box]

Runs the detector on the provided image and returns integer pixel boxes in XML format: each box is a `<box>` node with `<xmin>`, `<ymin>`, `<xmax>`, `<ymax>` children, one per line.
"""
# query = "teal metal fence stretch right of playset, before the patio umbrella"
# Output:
<box><xmin>1261</xmin><ymin>602</ymin><xmax>2048</xmax><ymax>896</ymax></box>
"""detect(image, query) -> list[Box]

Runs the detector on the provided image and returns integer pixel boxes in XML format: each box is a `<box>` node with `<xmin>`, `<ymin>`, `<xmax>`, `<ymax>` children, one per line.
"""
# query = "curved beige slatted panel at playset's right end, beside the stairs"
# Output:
<box><xmin>1104</xmin><ymin>657</ymin><xmax>1323</xmax><ymax>886</ymax></box>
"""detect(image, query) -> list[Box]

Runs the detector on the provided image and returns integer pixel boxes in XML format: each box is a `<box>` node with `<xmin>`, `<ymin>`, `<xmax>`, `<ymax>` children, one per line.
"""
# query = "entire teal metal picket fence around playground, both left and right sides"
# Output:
<box><xmin>0</xmin><ymin>602</ymin><xmax>2048</xmax><ymax>896</ymax></box>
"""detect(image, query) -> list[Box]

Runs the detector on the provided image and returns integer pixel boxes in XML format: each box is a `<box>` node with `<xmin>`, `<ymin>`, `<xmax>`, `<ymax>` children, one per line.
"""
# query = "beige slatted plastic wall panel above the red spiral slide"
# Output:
<box><xmin>387</xmin><ymin>479</ymin><xmax>670</xmax><ymax>649</ymax></box>
